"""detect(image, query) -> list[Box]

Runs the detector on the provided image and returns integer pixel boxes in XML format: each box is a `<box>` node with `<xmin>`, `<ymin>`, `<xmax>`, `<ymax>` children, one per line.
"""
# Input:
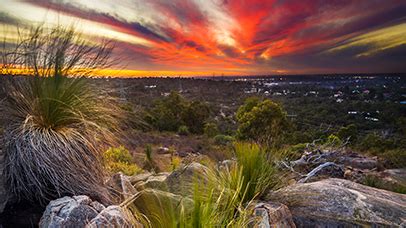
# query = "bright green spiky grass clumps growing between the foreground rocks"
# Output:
<box><xmin>126</xmin><ymin>143</ymin><xmax>278</xmax><ymax>227</ymax></box>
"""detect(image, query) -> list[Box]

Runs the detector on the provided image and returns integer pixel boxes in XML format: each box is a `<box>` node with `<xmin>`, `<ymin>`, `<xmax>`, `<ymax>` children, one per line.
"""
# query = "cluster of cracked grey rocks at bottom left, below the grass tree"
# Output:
<box><xmin>39</xmin><ymin>195</ymin><xmax>133</xmax><ymax>228</ymax></box>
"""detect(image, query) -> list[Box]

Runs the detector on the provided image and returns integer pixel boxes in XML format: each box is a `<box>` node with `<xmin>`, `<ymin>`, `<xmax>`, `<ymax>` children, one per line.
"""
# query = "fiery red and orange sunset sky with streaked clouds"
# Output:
<box><xmin>0</xmin><ymin>0</ymin><xmax>406</xmax><ymax>76</ymax></box>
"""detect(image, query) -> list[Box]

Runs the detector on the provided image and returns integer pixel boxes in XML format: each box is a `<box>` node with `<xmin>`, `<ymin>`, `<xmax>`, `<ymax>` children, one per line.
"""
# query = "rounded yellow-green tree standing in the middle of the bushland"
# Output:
<box><xmin>237</xmin><ymin>99</ymin><xmax>290</xmax><ymax>146</ymax></box>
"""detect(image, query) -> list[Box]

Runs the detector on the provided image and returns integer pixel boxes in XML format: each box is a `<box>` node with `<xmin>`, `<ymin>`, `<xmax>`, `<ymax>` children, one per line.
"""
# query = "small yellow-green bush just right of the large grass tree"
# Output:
<box><xmin>103</xmin><ymin>146</ymin><xmax>142</xmax><ymax>176</ymax></box>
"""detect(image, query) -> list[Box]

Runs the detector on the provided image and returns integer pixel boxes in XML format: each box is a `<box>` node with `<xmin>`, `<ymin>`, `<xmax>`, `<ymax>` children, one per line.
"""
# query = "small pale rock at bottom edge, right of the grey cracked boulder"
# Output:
<box><xmin>86</xmin><ymin>205</ymin><xmax>143</xmax><ymax>228</ymax></box>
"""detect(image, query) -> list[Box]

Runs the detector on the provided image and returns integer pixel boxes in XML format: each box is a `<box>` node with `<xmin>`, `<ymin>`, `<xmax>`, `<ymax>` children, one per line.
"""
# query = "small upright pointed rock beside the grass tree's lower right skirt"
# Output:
<box><xmin>106</xmin><ymin>172</ymin><xmax>137</xmax><ymax>202</ymax></box>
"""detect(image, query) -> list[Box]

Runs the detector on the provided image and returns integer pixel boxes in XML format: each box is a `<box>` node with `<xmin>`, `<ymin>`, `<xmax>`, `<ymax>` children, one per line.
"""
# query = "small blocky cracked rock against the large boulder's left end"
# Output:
<box><xmin>254</xmin><ymin>202</ymin><xmax>296</xmax><ymax>228</ymax></box>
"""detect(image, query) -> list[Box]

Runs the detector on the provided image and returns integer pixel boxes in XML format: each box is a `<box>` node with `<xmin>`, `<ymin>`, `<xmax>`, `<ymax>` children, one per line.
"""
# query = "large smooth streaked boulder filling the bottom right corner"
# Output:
<box><xmin>267</xmin><ymin>178</ymin><xmax>406</xmax><ymax>227</ymax></box>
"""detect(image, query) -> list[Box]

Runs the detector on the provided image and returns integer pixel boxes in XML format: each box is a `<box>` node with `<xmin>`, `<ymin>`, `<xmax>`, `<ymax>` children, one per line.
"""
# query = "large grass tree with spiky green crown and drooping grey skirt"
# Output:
<box><xmin>1</xmin><ymin>26</ymin><xmax>119</xmax><ymax>202</ymax></box>
